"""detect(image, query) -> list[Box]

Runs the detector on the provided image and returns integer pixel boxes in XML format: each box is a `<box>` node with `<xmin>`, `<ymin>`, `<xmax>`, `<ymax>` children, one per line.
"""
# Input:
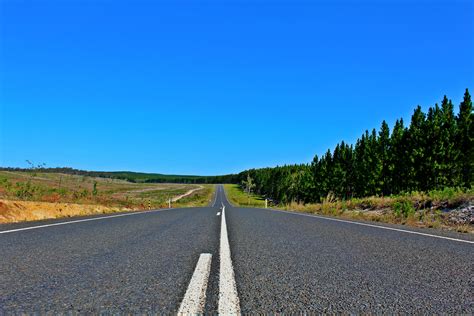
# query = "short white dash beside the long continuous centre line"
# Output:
<box><xmin>178</xmin><ymin>253</ymin><xmax>212</xmax><ymax>315</ymax></box>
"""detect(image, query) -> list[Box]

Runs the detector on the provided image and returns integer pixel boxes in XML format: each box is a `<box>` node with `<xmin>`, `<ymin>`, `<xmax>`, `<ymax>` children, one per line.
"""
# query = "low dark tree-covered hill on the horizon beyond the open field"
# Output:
<box><xmin>0</xmin><ymin>167</ymin><xmax>238</xmax><ymax>183</ymax></box>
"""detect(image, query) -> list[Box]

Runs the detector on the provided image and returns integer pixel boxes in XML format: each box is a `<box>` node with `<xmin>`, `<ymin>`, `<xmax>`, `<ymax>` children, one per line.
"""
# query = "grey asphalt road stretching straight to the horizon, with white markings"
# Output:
<box><xmin>0</xmin><ymin>187</ymin><xmax>474</xmax><ymax>314</ymax></box>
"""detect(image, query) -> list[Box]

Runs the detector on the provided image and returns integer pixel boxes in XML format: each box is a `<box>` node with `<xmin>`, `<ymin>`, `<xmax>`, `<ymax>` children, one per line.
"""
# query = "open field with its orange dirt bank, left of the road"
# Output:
<box><xmin>0</xmin><ymin>169</ymin><xmax>214</xmax><ymax>222</ymax></box>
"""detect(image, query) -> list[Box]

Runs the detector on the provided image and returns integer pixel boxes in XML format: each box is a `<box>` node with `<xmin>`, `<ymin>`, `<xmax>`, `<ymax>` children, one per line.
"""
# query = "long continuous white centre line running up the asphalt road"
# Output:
<box><xmin>218</xmin><ymin>207</ymin><xmax>240</xmax><ymax>315</ymax></box>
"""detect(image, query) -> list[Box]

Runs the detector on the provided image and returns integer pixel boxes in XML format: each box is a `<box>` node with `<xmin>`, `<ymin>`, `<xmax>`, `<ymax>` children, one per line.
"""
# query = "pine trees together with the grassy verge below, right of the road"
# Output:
<box><xmin>226</xmin><ymin>89</ymin><xmax>474</xmax><ymax>231</ymax></box>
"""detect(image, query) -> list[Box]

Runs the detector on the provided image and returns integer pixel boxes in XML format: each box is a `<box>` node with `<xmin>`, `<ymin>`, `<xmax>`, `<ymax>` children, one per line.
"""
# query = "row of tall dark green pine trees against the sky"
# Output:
<box><xmin>239</xmin><ymin>89</ymin><xmax>474</xmax><ymax>203</ymax></box>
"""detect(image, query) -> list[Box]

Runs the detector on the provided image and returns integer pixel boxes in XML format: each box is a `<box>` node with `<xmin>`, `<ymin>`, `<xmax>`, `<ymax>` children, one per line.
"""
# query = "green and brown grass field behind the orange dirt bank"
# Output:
<box><xmin>0</xmin><ymin>171</ymin><xmax>215</xmax><ymax>223</ymax></box>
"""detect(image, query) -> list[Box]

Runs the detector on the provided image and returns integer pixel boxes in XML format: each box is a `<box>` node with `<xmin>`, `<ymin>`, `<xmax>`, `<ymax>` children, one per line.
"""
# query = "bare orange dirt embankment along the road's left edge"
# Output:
<box><xmin>0</xmin><ymin>199</ymin><xmax>130</xmax><ymax>223</ymax></box>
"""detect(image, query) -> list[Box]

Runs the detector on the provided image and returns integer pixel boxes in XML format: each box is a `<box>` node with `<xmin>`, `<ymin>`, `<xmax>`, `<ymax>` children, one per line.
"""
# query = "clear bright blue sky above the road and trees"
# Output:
<box><xmin>0</xmin><ymin>0</ymin><xmax>474</xmax><ymax>175</ymax></box>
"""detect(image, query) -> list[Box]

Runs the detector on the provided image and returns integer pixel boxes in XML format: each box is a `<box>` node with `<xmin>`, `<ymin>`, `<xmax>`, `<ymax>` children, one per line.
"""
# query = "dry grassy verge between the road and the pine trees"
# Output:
<box><xmin>224</xmin><ymin>185</ymin><xmax>474</xmax><ymax>233</ymax></box>
